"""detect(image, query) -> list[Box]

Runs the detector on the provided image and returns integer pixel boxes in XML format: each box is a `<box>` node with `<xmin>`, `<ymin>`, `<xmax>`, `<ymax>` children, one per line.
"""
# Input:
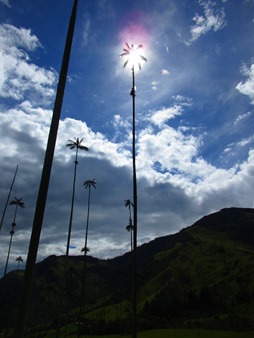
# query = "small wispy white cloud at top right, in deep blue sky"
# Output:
<box><xmin>188</xmin><ymin>0</ymin><xmax>226</xmax><ymax>43</ymax></box>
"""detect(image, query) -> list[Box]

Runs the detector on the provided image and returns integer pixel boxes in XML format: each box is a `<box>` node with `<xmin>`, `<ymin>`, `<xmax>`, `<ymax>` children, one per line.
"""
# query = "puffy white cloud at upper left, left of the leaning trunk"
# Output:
<box><xmin>0</xmin><ymin>24</ymin><xmax>56</xmax><ymax>102</ymax></box>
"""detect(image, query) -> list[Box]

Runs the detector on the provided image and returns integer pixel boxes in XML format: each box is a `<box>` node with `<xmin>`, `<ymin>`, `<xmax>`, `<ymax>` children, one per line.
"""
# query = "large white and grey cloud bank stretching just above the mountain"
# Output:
<box><xmin>0</xmin><ymin>88</ymin><xmax>254</xmax><ymax>274</ymax></box>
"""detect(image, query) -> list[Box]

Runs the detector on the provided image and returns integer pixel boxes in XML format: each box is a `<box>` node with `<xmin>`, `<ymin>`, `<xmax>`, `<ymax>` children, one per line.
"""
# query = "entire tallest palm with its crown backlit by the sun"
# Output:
<box><xmin>120</xmin><ymin>42</ymin><xmax>147</xmax><ymax>338</ymax></box>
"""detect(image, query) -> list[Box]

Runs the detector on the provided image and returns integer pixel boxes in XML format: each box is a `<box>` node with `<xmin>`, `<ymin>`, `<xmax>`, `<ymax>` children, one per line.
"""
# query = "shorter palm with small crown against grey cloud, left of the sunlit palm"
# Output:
<box><xmin>77</xmin><ymin>179</ymin><xmax>96</xmax><ymax>338</ymax></box>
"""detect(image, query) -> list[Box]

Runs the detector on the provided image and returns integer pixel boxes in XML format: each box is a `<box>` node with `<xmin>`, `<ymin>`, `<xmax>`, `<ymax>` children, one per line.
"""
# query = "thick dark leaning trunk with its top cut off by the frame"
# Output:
<box><xmin>14</xmin><ymin>0</ymin><xmax>78</xmax><ymax>338</ymax></box>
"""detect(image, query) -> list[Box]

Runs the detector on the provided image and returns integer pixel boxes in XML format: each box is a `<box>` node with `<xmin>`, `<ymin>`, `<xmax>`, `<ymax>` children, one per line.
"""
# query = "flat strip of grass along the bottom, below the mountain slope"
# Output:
<box><xmin>0</xmin><ymin>329</ymin><xmax>254</xmax><ymax>338</ymax></box>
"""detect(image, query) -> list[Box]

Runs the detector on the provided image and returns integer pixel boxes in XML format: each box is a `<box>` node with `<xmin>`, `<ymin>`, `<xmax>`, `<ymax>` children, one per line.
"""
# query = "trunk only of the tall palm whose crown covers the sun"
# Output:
<box><xmin>132</xmin><ymin>66</ymin><xmax>138</xmax><ymax>338</ymax></box>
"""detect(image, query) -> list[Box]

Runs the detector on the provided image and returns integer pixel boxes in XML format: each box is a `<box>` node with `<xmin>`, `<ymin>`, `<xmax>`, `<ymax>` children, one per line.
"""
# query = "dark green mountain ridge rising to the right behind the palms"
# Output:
<box><xmin>0</xmin><ymin>208</ymin><xmax>254</xmax><ymax>333</ymax></box>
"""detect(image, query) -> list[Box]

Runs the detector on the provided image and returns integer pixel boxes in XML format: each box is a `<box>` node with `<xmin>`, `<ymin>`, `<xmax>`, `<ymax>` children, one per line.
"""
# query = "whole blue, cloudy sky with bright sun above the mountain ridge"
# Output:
<box><xmin>0</xmin><ymin>0</ymin><xmax>254</xmax><ymax>273</ymax></box>
